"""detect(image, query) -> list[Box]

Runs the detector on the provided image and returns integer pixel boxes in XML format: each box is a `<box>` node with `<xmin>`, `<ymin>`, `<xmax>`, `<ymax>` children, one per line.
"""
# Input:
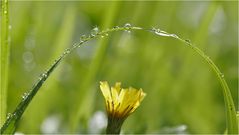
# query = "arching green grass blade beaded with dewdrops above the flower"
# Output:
<box><xmin>1</xmin><ymin>24</ymin><xmax>235</xmax><ymax>134</ymax></box>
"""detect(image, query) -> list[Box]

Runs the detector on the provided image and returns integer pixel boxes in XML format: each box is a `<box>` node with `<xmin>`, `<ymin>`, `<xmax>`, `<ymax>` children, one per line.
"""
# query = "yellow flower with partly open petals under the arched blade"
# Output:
<box><xmin>100</xmin><ymin>81</ymin><xmax>146</xmax><ymax>133</ymax></box>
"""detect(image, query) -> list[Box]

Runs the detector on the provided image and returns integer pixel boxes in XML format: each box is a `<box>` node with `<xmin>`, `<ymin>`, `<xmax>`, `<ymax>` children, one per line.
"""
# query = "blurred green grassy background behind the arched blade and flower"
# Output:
<box><xmin>4</xmin><ymin>1</ymin><xmax>238</xmax><ymax>133</ymax></box>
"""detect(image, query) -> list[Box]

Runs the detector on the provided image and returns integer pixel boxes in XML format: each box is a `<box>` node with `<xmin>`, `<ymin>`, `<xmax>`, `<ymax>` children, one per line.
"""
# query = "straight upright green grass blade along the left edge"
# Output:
<box><xmin>0</xmin><ymin>0</ymin><xmax>9</xmax><ymax>126</ymax></box>
